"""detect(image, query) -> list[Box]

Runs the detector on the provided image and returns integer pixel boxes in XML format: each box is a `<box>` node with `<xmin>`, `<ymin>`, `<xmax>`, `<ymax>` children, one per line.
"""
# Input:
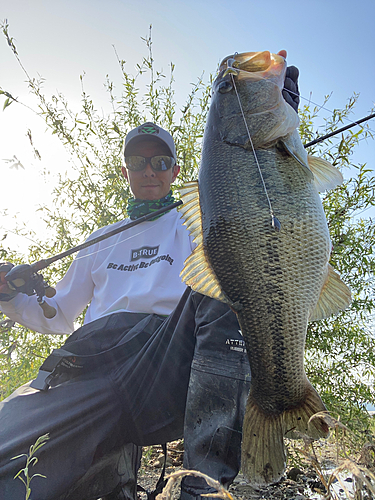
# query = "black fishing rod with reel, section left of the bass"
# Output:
<box><xmin>5</xmin><ymin>200</ymin><xmax>182</xmax><ymax>318</ymax></box>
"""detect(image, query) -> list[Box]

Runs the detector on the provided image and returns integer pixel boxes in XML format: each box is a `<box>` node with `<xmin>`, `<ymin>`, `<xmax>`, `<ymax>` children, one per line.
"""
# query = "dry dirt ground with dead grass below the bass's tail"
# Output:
<box><xmin>138</xmin><ymin>441</ymin><xmax>375</xmax><ymax>500</ymax></box>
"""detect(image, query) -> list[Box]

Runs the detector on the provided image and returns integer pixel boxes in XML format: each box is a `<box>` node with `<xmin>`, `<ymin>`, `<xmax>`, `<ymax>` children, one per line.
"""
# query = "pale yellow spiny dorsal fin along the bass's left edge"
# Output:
<box><xmin>178</xmin><ymin>181</ymin><xmax>230</xmax><ymax>304</ymax></box>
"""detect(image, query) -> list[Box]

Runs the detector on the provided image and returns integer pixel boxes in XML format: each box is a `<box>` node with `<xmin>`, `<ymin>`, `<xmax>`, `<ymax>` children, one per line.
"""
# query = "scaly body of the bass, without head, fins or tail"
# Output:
<box><xmin>199</xmin><ymin>143</ymin><xmax>331</xmax><ymax>404</ymax></box>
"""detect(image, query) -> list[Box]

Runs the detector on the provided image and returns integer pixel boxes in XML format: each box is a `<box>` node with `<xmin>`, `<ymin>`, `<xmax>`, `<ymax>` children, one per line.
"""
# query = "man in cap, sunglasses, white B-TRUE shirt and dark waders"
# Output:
<box><xmin>0</xmin><ymin>57</ymin><xmax>302</xmax><ymax>500</ymax></box>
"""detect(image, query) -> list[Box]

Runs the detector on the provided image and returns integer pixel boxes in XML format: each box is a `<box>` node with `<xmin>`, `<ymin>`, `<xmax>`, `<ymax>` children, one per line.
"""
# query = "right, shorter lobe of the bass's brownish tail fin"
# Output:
<box><xmin>284</xmin><ymin>380</ymin><xmax>329</xmax><ymax>439</ymax></box>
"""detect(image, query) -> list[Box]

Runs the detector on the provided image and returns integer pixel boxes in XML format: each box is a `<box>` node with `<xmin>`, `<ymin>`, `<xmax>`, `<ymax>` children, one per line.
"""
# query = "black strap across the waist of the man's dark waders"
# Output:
<box><xmin>30</xmin><ymin>331</ymin><xmax>150</xmax><ymax>391</ymax></box>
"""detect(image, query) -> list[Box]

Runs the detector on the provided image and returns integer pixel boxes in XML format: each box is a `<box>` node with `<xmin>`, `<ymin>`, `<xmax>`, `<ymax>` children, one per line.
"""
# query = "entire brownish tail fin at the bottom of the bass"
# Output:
<box><xmin>241</xmin><ymin>381</ymin><xmax>329</xmax><ymax>486</ymax></box>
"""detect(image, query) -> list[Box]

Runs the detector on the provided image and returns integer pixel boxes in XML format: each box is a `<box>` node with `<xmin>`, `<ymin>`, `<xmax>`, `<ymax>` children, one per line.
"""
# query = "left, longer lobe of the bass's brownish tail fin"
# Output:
<box><xmin>241</xmin><ymin>395</ymin><xmax>286</xmax><ymax>486</ymax></box>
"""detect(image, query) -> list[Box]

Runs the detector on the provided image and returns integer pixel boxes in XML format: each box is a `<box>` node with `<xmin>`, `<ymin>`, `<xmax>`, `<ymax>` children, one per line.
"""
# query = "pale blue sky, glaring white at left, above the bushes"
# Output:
<box><xmin>0</xmin><ymin>0</ymin><xmax>375</xmax><ymax>254</ymax></box>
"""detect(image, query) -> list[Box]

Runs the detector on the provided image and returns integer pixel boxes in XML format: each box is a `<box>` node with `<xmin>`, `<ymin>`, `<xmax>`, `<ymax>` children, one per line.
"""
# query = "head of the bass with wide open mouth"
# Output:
<box><xmin>211</xmin><ymin>51</ymin><xmax>299</xmax><ymax>152</ymax></box>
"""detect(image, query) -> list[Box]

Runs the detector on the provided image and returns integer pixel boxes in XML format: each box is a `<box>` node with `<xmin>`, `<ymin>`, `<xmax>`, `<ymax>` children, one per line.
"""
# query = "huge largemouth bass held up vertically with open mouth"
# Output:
<box><xmin>181</xmin><ymin>52</ymin><xmax>351</xmax><ymax>485</ymax></box>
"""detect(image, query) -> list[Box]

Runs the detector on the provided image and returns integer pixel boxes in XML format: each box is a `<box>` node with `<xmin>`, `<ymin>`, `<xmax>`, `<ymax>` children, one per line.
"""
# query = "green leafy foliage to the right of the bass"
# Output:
<box><xmin>300</xmin><ymin>95</ymin><xmax>375</xmax><ymax>430</ymax></box>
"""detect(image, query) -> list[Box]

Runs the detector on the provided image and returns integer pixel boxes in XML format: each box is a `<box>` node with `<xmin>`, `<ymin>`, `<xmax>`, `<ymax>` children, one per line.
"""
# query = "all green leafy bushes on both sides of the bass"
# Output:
<box><xmin>0</xmin><ymin>23</ymin><xmax>375</xmax><ymax>442</ymax></box>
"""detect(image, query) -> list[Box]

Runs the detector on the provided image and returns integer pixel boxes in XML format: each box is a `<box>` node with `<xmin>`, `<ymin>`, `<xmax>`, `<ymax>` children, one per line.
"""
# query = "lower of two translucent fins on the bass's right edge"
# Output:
<box><xmin>309</xmin><ymin>264</ymin><xmax>352</xmax><ymax>321</ymax></box>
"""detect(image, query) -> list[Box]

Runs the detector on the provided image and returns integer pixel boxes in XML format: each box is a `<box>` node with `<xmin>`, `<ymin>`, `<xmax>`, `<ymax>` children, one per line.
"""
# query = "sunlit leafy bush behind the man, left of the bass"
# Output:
<box><xmin>0</xmin><ymin>21</ymin><xmax>210</xmax><ymax>397</ymax></box>
